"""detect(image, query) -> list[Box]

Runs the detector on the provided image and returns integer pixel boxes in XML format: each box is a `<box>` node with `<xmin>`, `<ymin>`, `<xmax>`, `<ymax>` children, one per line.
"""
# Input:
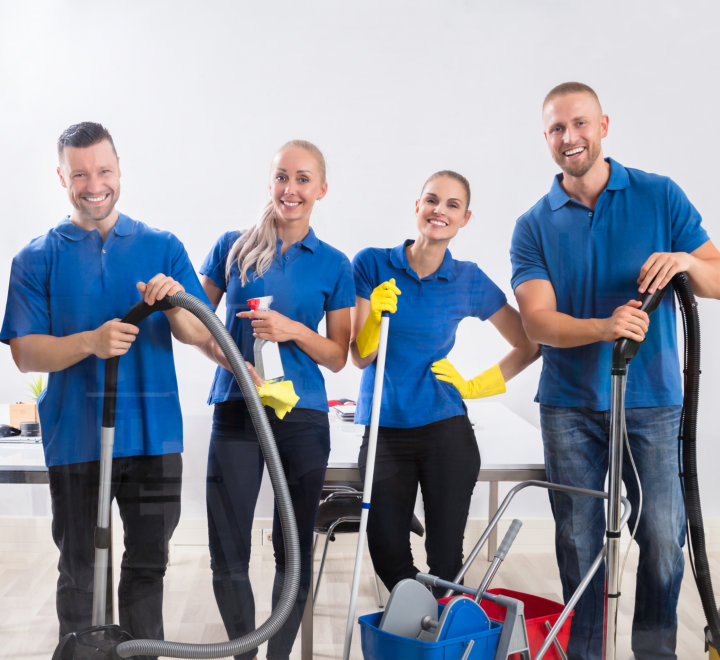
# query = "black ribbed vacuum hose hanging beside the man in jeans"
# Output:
<box><xmin>672</xmin><ymin>273</ymin><xmax>720</xmax><ymax>648</ymax></box>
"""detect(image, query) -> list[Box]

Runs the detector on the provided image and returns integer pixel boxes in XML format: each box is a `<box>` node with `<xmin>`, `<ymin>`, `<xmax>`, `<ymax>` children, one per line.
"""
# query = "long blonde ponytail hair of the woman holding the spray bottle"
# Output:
<box><xmin>225</xmin><ymin>140</ymin><xmax>326</xmax><ymax>286</ymax></box>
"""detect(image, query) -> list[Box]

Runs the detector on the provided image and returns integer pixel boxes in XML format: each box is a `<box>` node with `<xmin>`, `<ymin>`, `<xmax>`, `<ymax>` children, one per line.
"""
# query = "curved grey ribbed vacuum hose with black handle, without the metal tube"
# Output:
<box><xmin>103</xmin><ymin>292</ymin><xmax>300</xmax><ymax>658</ymax></box>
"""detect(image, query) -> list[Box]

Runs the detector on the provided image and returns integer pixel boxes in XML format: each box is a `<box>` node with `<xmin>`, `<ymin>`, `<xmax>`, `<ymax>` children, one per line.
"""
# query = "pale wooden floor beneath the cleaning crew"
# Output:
<box><xmin>0</xmin><ymin>519</ymin><xmax>720</xmax><ymax>660</ymax></box>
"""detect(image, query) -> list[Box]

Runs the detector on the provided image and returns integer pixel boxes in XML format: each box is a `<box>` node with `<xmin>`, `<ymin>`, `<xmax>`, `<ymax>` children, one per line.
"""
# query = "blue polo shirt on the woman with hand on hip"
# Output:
<box><xmin>353</xmin><ymin>240</ymin><xmax>507</xmax><ymax>428</ymax></box>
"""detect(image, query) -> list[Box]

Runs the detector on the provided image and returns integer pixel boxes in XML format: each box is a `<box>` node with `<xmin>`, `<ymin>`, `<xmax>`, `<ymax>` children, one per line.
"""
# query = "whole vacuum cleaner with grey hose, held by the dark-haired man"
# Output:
<box><xmin>53</xmin><ymin>291</ymin><xmax>300</xmax><ymax>660</ymax></box>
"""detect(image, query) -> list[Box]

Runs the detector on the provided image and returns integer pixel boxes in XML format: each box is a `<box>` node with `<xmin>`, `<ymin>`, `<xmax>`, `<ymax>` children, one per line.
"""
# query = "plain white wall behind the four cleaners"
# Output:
<box><xmin>0</xmin><ymin>0</ymin><xmax>720</xmax><ymax>515</ymax></box>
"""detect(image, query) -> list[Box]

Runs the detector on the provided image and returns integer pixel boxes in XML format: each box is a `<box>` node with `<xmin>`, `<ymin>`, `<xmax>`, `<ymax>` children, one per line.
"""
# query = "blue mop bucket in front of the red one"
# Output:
<box><xmin>358</xmin><ymin>605</ymin><xmax>502</xmax><ymax>660</ymax></box>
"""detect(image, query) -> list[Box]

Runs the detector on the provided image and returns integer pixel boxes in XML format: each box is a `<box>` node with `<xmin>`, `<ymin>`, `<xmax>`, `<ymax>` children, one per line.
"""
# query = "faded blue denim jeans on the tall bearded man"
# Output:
<box><xmin>540</xmin><ymin>405</ymin><xmax>685</xmax><ymax>660</ymax></box>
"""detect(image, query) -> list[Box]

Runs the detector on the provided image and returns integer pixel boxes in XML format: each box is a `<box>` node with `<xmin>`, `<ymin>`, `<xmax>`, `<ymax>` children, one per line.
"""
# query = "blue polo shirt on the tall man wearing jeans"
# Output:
<box><xmin>510</xmin><ymin>158</ymin><xmax>708</xmax><ymax>410</ymax></box>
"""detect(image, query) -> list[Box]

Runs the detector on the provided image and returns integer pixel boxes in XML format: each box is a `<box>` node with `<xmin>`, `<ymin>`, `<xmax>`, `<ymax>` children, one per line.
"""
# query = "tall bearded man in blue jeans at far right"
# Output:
<box><xmin>510</xmin><ymin>83</ymin><xmax>720</xmax><ymax>660</ymax></box>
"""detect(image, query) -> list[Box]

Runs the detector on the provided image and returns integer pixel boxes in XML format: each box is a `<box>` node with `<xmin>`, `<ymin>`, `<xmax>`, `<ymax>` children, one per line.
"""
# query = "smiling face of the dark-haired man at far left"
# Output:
<box><xmin>57</xmin><ymin>140</ymin><xmax>120</xmax><ymax>233</ymax></box>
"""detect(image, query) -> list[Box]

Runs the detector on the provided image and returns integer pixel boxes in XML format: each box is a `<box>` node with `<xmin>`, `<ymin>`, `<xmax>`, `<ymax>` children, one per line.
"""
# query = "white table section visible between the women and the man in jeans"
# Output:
<box><xmin>301</xmin><ymin>399</ymin><xmax>545</xmax><ymax>660</ymax></box>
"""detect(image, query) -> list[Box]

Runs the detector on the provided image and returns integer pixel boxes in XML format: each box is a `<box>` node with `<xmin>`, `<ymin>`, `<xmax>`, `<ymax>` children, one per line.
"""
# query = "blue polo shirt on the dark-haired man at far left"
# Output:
<box><xmin>0</xmin><ymin>214</ymin><xmax>207</xmax><ymax>466</ymax></box>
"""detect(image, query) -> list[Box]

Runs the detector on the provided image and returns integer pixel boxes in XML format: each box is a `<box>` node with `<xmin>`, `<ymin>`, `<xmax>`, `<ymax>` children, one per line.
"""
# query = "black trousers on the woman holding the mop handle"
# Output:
<box><xmin>358</xmin><ymin>415</ymin><xmax>480</xmax><ymax>595</ymax></box>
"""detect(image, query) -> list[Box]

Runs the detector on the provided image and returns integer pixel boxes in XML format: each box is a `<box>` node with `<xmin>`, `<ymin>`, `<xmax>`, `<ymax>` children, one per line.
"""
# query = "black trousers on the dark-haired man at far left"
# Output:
<box><xmin>48</xmin><ymin>454</ymin><xmax>182</xmax><ymax>639</ymax></box>
